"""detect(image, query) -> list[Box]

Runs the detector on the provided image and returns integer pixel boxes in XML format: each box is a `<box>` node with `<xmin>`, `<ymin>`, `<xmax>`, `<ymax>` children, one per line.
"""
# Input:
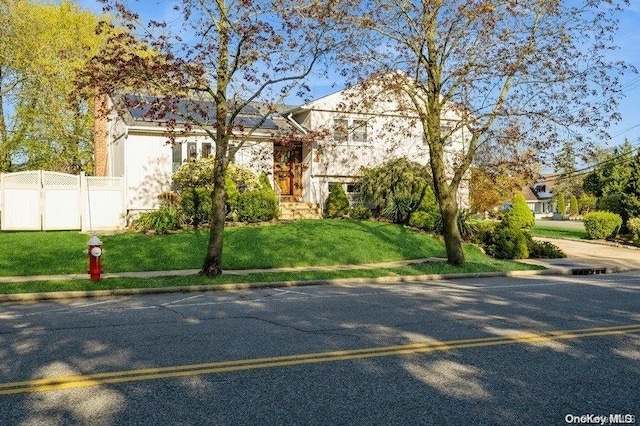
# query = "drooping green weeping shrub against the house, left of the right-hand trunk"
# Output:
<box><xmin>360</xmin><ymin>158</ymin><xmax>435</xmax><ymax>224</ymax></box>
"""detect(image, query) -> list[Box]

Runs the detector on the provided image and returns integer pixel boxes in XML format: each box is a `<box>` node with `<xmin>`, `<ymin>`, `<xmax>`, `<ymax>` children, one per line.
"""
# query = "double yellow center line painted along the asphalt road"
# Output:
<box><xmin>0</xmin><ymin>324</ymin><xmax>640</xmax><ymax>395</ymax></box>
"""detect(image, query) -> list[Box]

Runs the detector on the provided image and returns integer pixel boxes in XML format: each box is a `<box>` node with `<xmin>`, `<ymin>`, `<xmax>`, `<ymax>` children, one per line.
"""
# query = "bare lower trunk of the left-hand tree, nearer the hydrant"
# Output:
<box><xmin>200</xmin><ymin>160</ymin><xmax>227</xmax><ymax>277</ymax></box>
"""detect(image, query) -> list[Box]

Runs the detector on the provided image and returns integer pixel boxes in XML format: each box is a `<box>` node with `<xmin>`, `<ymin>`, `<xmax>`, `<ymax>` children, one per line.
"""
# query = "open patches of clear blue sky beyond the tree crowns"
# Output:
<box><xmin>77</xmin><ymin>0</ymin><xmax>640</xmax><ymax>150</ymax></box>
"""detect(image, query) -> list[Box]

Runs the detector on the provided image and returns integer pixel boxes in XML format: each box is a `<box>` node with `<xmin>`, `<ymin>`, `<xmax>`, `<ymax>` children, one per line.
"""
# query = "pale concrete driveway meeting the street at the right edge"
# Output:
<box><xmin>528</xmin><ymin>238</ymin><xmax>640</xmax><ymax>272</ymax></box>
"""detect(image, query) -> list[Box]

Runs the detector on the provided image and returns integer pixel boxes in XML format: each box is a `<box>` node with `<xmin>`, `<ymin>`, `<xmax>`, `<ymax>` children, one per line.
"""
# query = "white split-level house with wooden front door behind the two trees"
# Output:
<box><xmin>95</xmin><ymin>79</ymin><xmax>468</xmax><ymax>223</ymax></box>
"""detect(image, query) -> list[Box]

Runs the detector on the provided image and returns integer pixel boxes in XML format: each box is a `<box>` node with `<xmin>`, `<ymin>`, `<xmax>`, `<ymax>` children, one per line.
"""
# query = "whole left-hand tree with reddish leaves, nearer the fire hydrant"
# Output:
<box><xmin>81</xmin><ymin>0</ymin><xmax>349</xmax><ymax>276</ymax></box>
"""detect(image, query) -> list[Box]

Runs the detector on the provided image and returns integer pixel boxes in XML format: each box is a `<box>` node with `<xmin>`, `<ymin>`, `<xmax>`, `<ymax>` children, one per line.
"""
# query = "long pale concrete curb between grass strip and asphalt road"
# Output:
<box><xmin>0</xmin><ymin>267</ymin><xmax>631</xmax><ymax>303</ymax></box>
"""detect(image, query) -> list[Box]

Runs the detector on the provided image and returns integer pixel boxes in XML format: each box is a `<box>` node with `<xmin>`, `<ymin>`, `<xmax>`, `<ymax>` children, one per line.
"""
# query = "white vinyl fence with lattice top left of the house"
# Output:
<box><xmin>0</xmin><ymin>170</ymin><xmax>126</xmax><ymax>231</ymax></box>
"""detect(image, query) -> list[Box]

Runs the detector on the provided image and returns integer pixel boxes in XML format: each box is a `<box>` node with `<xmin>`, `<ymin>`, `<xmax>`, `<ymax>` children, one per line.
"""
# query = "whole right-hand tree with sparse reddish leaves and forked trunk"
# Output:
<box><xmin>345</xmin><ymin>0</ymin><xmax>629</xmax><ymax>265</ymax></box>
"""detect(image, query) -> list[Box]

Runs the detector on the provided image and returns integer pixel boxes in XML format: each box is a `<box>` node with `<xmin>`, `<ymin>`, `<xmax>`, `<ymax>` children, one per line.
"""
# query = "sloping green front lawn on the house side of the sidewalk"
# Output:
<box><xmin>0</xmin><ymin>220</ymin><xmax>536</xmax><ymax>279</ymax></box>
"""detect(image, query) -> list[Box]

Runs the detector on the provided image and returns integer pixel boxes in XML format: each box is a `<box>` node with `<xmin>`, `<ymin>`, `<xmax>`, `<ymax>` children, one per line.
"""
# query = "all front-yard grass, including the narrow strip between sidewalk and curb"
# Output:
<box><xmin>0</xmin><ymin>220</ymin><xmax>540</xmax><ymax>294</ymax></box>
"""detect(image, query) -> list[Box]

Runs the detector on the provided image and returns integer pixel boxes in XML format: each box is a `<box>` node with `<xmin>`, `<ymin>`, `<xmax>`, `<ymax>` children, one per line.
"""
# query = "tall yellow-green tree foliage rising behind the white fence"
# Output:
<box><xmin>0</xmin><ymin>0</ymin><xmax>105</xmax><ymax>173</ymax></box>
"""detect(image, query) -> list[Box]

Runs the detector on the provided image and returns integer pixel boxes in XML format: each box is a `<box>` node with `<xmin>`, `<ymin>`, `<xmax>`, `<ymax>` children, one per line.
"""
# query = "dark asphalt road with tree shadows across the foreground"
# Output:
<box><xmin>0</xmin><ymin>273</ymin><xmax>640</xmax><ymax>425</ymax></box>
